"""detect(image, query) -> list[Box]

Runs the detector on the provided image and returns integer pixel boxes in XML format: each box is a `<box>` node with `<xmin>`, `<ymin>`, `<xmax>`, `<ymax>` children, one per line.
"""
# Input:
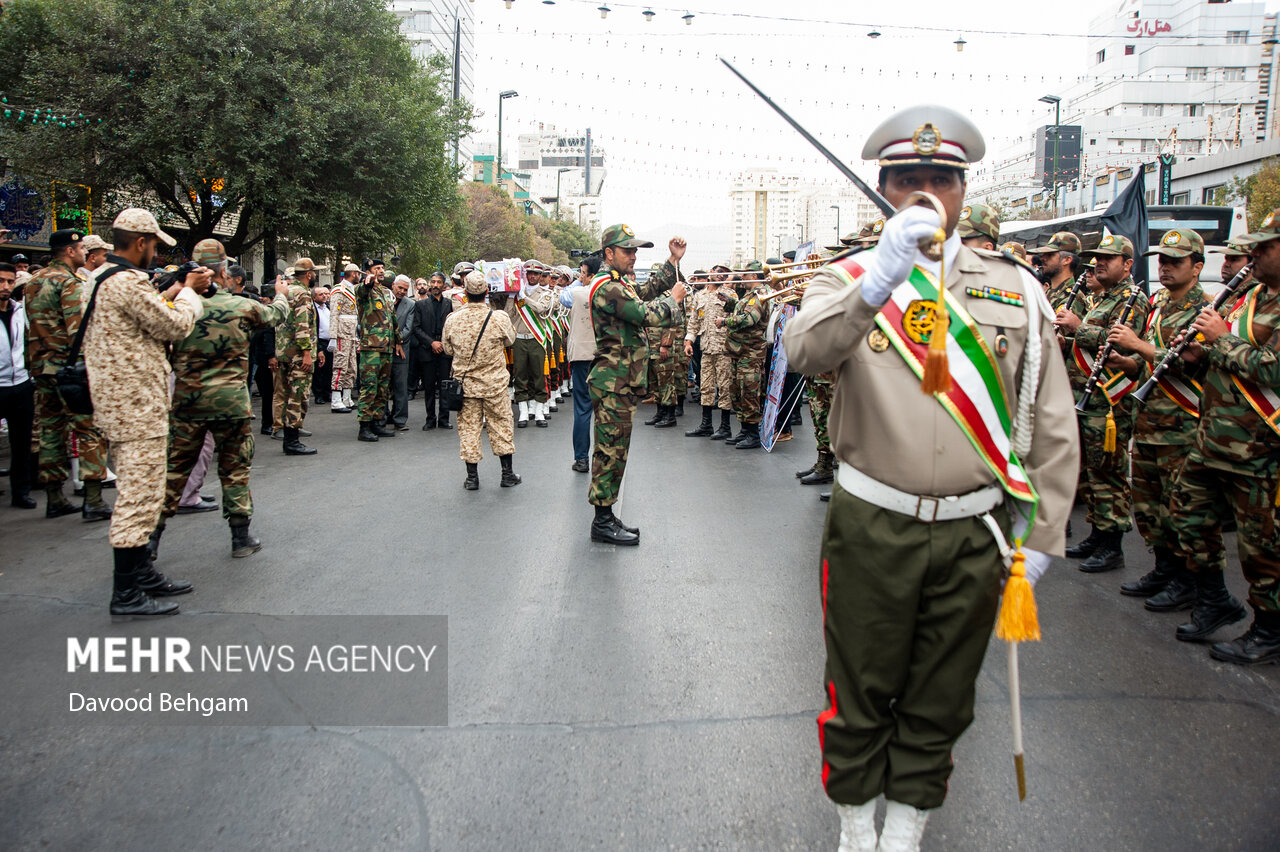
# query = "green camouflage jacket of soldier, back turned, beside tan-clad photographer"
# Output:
<box><xmin>170</xmin><ymin>290</ymin><xmax>291</xmax><ymax>420</ymax></box>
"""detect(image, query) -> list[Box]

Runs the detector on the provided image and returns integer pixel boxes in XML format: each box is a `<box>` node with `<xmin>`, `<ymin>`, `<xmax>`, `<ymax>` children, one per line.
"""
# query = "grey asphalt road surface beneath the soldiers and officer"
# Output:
<box><xmin>0</xmin><ymin>402</ymin><xmax>1280</xmax><ymax>852</ymax></box>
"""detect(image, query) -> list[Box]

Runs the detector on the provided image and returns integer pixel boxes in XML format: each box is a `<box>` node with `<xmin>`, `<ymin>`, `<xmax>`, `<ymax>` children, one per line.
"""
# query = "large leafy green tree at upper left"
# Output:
<box><xmin>0</xmin><ymin>0</ymin><xmax>470</xmax><ymax>255</ymax></box>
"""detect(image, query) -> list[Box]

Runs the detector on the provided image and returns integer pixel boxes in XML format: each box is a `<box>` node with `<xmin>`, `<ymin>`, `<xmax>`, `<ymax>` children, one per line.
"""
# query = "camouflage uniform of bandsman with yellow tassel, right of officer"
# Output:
<box><xmin>1068</xmin><ymin>278</ymin><xmax>1151</xmax><ymax>532</ymax></box>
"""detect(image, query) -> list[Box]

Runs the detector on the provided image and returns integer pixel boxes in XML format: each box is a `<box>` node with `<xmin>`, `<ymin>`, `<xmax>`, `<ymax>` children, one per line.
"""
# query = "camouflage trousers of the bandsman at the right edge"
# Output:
<box><xmin>1171</xmin><ymin>448</ymin><xmax>1280</xmax><ymax>613</ymax></box>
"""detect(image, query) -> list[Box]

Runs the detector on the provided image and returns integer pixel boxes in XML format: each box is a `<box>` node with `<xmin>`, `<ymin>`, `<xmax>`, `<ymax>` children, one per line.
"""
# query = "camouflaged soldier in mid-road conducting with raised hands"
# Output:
<box><xmin>588</xmin><ymin>225</ymin><xmax>686</xmax><ymax>545</ymax></box>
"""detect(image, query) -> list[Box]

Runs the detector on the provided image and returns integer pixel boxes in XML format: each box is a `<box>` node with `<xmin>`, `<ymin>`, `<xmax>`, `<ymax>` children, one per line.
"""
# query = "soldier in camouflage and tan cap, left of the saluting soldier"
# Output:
<box><xmin>275</xmin><ymin>257</ymin><xmax>324</xmax><ymax>455</ymax></box>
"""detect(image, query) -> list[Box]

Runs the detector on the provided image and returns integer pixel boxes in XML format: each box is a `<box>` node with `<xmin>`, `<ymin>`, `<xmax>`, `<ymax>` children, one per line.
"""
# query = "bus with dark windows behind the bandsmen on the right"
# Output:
<box><xmin>1000</xmin><ymin>205</ymin><xmax>1249</xmax><ymax>289</ymax></box>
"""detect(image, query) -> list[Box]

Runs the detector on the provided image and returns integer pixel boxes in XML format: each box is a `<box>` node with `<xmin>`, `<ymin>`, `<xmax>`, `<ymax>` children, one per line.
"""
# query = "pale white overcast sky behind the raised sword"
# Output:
<box><xmin>471</xmin><ymin>0</ymin><xmax>1280</xmax><ymax>266</ymax></box>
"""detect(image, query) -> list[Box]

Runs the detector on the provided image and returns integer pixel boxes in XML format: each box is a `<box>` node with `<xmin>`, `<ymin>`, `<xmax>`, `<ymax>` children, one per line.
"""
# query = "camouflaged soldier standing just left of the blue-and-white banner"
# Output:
<box><xmin>719</xmin><ymin>261</ymin><xmax>769</xmax><ymax>449</ymax></box>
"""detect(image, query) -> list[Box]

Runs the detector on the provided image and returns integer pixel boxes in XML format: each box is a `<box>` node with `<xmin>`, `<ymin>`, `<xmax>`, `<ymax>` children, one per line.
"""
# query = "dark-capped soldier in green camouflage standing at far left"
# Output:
<box><xmin>23</xmin><ymin>229</ymin><xmax>111</xmax><ymax>521</ymax></box>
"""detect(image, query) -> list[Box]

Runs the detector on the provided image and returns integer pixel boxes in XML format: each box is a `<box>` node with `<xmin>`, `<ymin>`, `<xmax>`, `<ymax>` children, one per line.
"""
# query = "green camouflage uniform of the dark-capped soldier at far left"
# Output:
<box><xmin>23</xmin><ymin>260</ymin><xmax>106</xmax><ymax>485</ymax></box>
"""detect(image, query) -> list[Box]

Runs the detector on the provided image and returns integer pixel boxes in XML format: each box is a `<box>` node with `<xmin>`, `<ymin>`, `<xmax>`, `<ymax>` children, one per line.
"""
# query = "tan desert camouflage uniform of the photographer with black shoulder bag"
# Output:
<box><xmin>84</xmin><ymin>255</ymin><xmax>204</xmax><ymax>548</ymax></box>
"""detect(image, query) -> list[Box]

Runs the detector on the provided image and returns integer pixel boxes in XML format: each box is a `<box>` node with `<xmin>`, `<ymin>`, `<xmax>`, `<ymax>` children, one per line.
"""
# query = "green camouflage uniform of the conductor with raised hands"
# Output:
<box><xmin>588</xmin><ymin>260</ymin><xmax>680</xmax><ymax>505</ymax></box>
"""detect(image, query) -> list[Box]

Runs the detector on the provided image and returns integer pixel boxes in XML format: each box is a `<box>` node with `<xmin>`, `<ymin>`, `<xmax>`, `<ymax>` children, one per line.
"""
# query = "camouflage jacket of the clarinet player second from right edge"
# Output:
<box><xmin>1133</xmin><ymin>284</ymin><xmax>1208</xmax><ymax>448</ymax></box>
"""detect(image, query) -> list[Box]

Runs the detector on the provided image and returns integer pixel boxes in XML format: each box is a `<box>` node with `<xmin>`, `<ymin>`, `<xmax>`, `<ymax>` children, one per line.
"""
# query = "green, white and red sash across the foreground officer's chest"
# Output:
<box><xmin>828</xmin><ymin>257</ymin><xmax>1039</xmax><ymax>512</ymax></box>
